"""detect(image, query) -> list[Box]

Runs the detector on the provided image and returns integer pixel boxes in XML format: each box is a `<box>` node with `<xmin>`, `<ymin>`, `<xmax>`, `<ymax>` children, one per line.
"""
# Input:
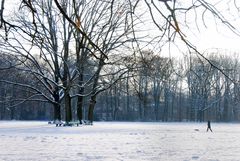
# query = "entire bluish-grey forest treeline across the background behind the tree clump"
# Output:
<box><xmin>0</xmin><ymin>51</ymin><xmax>240</xmax><ymax>121</ymax></box>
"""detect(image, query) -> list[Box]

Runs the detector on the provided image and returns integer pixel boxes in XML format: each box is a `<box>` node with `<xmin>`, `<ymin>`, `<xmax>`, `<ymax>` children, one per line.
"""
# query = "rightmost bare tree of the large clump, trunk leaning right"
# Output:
<box><xmin>68</xmin><ymin>1</ymin><xmax>136</xmax><ymax>122</ymax></box>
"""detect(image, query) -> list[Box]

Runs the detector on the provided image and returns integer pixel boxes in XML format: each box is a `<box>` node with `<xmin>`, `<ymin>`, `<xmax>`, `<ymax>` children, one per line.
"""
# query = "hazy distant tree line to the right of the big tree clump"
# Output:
<box><xmin>96</xmin><ymin>52</ymin><xmax>240</xmax><ymax>122</ymax></box>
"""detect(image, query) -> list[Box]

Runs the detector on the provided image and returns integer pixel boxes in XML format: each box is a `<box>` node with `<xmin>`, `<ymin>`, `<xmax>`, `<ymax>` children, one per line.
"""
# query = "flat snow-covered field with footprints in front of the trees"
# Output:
<box><xmin>0</xmin><ymin>121</ymin><xmax>240</xmax><ymax>161</ymax></box>
